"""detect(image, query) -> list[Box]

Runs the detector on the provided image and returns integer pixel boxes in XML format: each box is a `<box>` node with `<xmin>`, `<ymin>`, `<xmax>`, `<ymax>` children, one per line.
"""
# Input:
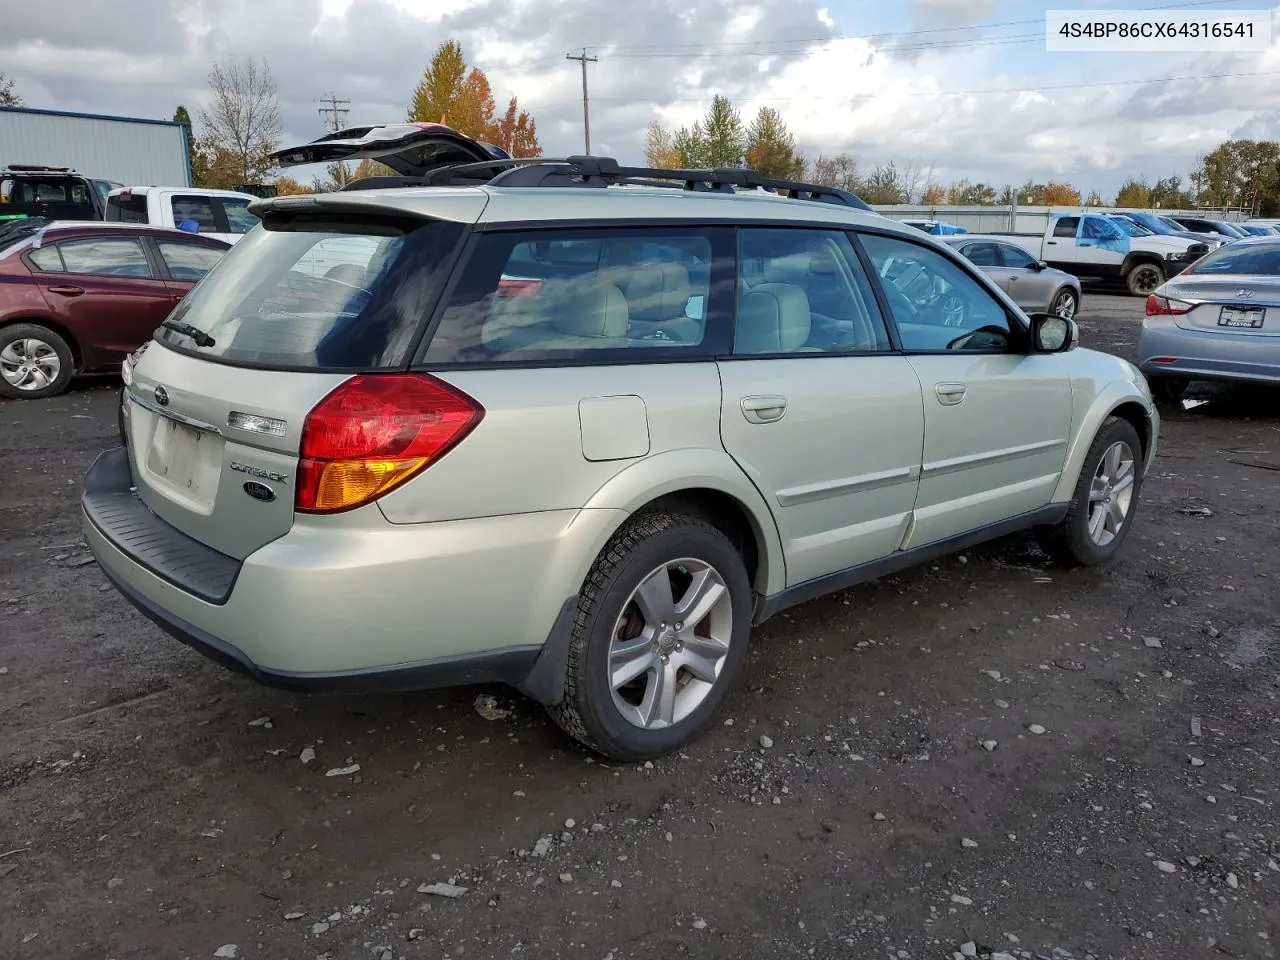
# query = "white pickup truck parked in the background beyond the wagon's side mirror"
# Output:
<box><xmin>993</xmin><ymin>214</ymin><xmax>1208</xmax><ymax>297</ymax></box>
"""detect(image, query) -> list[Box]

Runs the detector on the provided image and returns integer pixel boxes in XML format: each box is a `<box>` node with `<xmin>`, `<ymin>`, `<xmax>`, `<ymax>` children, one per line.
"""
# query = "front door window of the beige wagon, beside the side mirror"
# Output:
<box><xmin>861</xmin><ymin>234</ymin><xmax>1015</xmax><ymax>353</ymax></box>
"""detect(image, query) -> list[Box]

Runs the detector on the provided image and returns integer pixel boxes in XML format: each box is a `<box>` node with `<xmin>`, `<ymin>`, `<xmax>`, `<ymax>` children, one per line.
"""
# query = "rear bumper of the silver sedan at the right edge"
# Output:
<box><xmin>1138</xmin><ymin>317</ymin><xmax>1280</xmax><ymax>383</ymax></box>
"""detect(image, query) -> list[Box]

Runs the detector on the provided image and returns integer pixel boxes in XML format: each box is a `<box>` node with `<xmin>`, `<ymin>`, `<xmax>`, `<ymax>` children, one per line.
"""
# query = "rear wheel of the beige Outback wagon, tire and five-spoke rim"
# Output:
<box><xmin>548</xmin><ymin>513</ymin><xmax>751</xmax><ymax>760</ymax></box>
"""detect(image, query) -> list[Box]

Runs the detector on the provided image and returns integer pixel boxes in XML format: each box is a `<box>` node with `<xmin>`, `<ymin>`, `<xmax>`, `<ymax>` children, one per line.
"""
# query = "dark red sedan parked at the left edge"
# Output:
<box><xmin>0</xmin><ymin>218</ymin><xmax>230</xmax><ymax>399</ymax></box>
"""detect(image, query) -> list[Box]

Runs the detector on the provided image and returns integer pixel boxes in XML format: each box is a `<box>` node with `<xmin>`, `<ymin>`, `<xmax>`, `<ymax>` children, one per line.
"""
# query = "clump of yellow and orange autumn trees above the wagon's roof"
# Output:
<box><xmin>408</xmin><ymin>40</ymin><xmax>541</xmax><ymax>156</ymax></box>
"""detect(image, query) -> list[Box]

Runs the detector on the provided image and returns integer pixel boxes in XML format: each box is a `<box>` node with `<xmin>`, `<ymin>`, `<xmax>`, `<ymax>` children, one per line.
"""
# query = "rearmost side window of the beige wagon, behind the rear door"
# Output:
<box><xmin>421</xmin><ymin>227</ymin><xmax>733</xmax><ymax>365</ymax></box>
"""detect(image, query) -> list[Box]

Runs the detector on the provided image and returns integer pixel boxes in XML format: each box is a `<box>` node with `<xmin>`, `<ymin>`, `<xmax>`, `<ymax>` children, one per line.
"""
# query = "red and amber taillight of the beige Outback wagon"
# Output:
<box><xmin>294</xmin><ymin>374</ymin><xmax>484</xmax><ymax>513</ymax></box>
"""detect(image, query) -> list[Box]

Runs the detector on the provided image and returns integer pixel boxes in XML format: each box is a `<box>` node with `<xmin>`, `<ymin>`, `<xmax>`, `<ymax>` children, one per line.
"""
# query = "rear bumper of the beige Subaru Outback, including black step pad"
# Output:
<box><xmin>82</xmin><ymin>448</ymin><xmax>618</xmax><ymax>696</ymax></box>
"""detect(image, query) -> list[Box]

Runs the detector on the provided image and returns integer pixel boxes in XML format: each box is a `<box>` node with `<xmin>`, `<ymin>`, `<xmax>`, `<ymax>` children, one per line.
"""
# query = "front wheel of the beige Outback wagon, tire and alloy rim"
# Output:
<box><xmin>1044</xmin><ymin>417</ymin><xmax>1142</xmax><ymax>567</ymax></box>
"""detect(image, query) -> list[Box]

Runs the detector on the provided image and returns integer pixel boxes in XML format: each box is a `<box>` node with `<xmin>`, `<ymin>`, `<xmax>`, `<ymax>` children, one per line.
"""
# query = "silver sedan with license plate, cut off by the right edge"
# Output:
<box><xmin>1138</xmin><ymin>237</ymin><xmax>1280</xmax><ymax>399</ymax></box>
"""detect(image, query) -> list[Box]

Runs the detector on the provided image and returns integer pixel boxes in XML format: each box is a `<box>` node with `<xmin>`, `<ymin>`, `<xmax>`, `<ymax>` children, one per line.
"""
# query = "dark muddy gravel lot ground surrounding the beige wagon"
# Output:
<box><xmin>0</xmin><ymin>294</ymin><xmax>1280</xmax><ymax>960</ymax></box>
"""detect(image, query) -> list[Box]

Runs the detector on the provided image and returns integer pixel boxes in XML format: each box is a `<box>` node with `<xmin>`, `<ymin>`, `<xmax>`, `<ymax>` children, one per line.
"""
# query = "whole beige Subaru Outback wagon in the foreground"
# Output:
<box><xmin>82</xmin><ymin>124</ymin><xmax>1158</xmax><ymax>759</ymax></box>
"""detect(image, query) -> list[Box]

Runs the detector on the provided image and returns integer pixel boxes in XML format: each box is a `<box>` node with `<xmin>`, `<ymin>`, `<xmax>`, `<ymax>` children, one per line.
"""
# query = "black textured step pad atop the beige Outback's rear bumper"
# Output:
<box><xmin>81</xmin><ymin>447</ymin><xmax>241</xmax><ymax>604</ymax></box>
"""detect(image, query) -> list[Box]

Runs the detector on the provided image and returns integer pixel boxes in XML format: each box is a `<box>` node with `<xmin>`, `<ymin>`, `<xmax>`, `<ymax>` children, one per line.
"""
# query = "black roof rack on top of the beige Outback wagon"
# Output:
<box><xmin>343</xmin><ymin>156</ymin><xmax>870</xmax><ymax>210</ymax></box>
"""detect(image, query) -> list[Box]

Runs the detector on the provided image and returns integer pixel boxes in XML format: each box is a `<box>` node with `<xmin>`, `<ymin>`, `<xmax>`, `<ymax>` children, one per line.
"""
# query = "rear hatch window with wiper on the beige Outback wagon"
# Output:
<box><xmin>156</xmin><ymin>215</ymin><xmax>465</xmax><ymax>371</ymax></box>
